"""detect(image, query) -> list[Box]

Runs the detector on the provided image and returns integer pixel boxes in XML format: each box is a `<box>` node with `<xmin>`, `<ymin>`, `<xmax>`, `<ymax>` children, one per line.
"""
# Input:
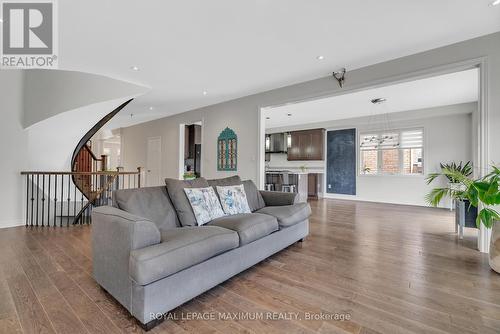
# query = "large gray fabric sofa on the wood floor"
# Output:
<box><xmin>92</xmin><ymin>177</ymin><xmax>311</xmax><ymax>330</ymax></box>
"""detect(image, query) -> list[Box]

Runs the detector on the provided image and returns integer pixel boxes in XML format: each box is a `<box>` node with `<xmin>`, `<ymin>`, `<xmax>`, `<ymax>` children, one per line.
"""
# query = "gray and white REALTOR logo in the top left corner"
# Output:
<box><xmin>0</xmin><ymin>0</ymin><xmax>57</xmax><ymax>68</ymax></box>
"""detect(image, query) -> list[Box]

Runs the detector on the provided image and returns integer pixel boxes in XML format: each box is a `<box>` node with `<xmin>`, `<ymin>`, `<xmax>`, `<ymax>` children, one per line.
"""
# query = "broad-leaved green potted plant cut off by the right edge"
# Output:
<box><xmin>428</xmin><ymin>166</ymin><xmax>500</xmax><ymax>273</ymax></box>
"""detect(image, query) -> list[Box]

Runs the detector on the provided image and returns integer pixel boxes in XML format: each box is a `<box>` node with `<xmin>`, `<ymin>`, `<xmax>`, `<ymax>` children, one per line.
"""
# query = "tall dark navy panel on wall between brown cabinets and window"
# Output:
<box><xmin>326</xmin><ymin>129</ymin><xmax>356</xmax><ymax>195</ymax></box>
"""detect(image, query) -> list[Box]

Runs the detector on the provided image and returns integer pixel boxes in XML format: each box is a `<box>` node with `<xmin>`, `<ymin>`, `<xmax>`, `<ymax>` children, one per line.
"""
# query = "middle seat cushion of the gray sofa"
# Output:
<box><xmin>209</xmin><ymin>213</ymin><xmax>279</xmax><ymax>246</ymax></box>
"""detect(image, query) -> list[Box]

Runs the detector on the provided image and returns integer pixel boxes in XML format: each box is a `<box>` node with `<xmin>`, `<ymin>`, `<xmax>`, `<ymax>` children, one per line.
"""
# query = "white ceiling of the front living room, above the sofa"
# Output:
<box><xmin>58</xmin><ymin>0</ymin><xmax>500</xmax><ymax>126</ymax></box>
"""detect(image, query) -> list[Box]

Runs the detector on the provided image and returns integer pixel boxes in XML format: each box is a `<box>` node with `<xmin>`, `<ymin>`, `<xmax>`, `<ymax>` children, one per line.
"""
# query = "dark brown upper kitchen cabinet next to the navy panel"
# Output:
<box><xmin>288</xmin><ymin>129</ymin><xmax>325</xmax><ymax>161</ymax></box>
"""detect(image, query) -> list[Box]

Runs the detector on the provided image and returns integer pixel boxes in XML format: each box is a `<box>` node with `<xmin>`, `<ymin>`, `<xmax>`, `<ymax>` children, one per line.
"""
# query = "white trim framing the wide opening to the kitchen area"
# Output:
<box><xmin>257</xmin><ymin>57</ymin><xmax>491</xmax><ymax>253</ymax></box>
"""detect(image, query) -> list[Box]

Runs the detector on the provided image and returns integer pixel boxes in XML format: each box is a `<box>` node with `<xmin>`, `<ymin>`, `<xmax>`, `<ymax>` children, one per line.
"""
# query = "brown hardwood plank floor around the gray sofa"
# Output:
<box><xmin>0</xmin><ymin>200</ymin><xmax>500</xmax><ymax>334</ymax></box>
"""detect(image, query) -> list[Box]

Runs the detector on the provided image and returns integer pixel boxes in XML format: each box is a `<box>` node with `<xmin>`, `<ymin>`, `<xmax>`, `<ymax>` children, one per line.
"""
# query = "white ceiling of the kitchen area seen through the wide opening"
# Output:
<box><xmin>264</xmin><ymin>69</ymin><xmax>479</xmax><ymax>129</ymax></box>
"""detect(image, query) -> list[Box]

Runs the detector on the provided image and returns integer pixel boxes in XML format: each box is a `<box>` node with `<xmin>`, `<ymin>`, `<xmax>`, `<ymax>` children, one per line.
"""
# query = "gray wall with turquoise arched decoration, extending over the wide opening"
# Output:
<box><xmin>122</xmin><ymin>33</ymin><xmax>500</xmax><ymax>187</ymax></box>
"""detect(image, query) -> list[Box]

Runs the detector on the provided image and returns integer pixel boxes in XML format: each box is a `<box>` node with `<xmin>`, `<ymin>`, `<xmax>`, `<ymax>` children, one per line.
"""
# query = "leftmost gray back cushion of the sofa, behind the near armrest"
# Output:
<box><xmin>113</xmin><ymin>186</ymin><xmax>180</xmax><ymax>230</ymax></box>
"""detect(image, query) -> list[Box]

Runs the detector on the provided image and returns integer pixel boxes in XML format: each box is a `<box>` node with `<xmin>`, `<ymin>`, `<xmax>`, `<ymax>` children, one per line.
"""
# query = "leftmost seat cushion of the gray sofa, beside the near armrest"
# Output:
<box><xmin>129</xmin><ymin>226</ymin><xmax>239</xmax><ymax>285</ymax></box>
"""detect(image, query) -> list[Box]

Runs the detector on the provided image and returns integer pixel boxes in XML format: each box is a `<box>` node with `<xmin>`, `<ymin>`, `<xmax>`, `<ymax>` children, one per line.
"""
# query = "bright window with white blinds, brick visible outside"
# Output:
<box><xmin>359</xmin><ymin>129</ymin><xmax>424</xmax><ymax>175</ymax></box>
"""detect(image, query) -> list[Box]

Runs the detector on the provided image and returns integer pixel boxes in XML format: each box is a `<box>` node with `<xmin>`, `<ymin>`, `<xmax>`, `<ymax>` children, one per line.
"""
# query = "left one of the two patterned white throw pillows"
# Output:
<box><xmin>184</xmin><ymin>187</ymin><xmax>226</xmax><ymax>225</ymax></box>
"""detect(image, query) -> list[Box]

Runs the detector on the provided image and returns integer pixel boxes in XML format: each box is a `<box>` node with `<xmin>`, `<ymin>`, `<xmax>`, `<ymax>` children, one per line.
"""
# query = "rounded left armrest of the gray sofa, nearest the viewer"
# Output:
<box><xmin>92</xmin><ymin>206</ymin><xmax>161</xmax><ymax>311</ymax></box>
